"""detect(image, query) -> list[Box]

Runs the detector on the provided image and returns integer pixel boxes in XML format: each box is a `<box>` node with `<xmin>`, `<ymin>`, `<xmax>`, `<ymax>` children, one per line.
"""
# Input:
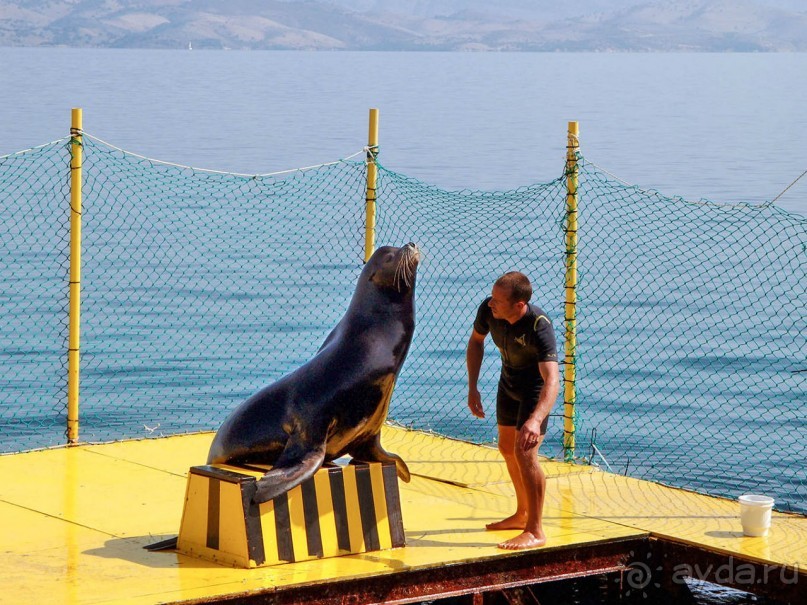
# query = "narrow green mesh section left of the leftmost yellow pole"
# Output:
<box><xmin>0</xmin><ymin>140</ymin><xmax>70</xmax><ymax>444</ymax></box>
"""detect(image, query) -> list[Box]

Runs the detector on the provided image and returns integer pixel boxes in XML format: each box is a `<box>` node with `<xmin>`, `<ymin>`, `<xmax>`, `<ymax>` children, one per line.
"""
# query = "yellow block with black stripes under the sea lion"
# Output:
<box><xmin>177</xmin><ymin>462</ymin><xmax>405</xmax><ymax>567</ymax></box>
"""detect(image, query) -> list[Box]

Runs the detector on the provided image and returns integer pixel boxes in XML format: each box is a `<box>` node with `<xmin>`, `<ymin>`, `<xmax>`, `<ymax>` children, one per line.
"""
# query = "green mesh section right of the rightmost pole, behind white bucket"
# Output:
<box><xmin>577</xmin><ymin>162</ymin><xmax>807</xmax><ymax>512</ymax></box>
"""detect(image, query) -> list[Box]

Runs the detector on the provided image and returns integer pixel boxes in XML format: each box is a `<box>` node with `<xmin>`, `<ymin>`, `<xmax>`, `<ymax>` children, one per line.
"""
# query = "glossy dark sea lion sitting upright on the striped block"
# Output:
<box><xmin>207</xmin><ymin>243</ymin><xmax>420</xmax><ymax>502</ymax></box>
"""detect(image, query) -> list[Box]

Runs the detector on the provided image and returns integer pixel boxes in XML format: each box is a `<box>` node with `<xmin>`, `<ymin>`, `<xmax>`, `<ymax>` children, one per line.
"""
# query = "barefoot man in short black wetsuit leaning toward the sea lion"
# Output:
<box><xmin>466</xmin><ymin>271</ymin><xmax>560</xmax><ymax>550</ymax></box>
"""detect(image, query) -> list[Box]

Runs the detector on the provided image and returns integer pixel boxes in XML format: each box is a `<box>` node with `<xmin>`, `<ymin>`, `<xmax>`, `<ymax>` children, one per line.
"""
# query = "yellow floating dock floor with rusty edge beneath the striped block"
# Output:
<box><xmin>0</xmin><ymin>427</ymin><xmax>807</xmax><ymax>605</ymax></box>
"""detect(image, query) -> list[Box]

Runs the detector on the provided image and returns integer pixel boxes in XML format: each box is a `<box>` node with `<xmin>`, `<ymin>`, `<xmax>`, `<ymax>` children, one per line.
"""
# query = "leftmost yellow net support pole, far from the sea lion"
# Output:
<box><xmin>67</xmin><ymin>107</ymin><xmax>83</xmax><ymax>444</ymax></box>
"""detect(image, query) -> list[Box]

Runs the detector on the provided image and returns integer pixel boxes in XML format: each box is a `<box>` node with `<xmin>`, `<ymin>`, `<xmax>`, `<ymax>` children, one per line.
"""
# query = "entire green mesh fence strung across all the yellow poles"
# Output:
<box><xmin>0</xmin><ymin>136</ymin><xmax>807</xmax><ymax>511</ymax></box>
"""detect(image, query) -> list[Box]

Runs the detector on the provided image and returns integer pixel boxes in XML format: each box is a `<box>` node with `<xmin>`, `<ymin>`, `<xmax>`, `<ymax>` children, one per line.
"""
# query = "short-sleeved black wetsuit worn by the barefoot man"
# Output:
<box><xmin>474</xmin><ymin>298</ymin><xmax>558</xmax><ymax>434</ymax></box>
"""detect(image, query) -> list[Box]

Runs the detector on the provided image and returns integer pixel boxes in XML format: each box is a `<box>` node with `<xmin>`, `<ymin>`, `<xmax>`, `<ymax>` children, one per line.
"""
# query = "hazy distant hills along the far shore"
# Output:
<box><xmin>0</xmin><ymin>0</ymin><xmax>807</xmax><ymax>52</ymax></box>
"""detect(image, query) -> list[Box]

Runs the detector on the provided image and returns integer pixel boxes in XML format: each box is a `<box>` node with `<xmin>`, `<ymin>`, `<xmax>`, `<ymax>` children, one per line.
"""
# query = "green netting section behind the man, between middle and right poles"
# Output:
<box><xmin>370</xmin><ymin>168</ymin><xmax>566</xmax><ymax>446</ymax></box>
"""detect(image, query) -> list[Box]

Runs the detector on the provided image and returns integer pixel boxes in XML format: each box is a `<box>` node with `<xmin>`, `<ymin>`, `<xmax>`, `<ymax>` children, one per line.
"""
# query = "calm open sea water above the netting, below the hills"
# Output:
<box><xmin>0</xmin><ymin>49</ymin><xmax>807</xmax><ymax>602</ymax></box>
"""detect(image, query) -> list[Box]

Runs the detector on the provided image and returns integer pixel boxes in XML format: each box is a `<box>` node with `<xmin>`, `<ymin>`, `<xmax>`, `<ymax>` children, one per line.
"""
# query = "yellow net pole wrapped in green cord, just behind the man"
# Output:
<box><xmin>563</xmin><ymin>122</ymin><xmax>580</xmax><ymax>462</ymax></box>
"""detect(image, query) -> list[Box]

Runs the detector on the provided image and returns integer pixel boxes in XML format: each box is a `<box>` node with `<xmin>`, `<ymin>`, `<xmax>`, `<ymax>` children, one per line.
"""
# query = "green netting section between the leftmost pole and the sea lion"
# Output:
<box><xmin>75</xmin><ymin>139</ymin><xmax>365</xmax><ymax>440</ymax></box>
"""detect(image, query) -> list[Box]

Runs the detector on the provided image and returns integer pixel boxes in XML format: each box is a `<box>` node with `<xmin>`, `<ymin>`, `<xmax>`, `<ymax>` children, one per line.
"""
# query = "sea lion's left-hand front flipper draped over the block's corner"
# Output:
<box><xmin>252</xmin><ymin>434</ymin><xmax>325</xmax><ymax>502</ymax></box>
